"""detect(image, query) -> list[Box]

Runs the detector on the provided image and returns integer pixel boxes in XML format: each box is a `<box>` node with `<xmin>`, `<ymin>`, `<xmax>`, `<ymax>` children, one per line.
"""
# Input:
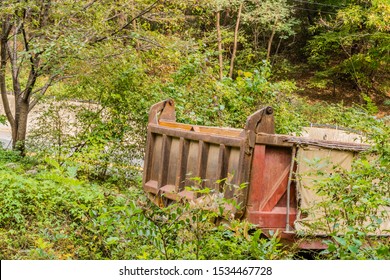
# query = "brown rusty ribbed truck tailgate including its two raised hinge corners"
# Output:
<box><xmin>143</xmin><ymin>100</ymin><xmax>273</xmax><ymax>215</ymax></box>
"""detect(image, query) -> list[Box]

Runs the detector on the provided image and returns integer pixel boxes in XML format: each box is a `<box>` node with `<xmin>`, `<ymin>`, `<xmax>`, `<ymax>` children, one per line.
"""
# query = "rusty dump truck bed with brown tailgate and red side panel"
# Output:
<box><xmin>143</xmin><ymin>100</ymin><xmax>386</xmax><ymax>248</ymax></box>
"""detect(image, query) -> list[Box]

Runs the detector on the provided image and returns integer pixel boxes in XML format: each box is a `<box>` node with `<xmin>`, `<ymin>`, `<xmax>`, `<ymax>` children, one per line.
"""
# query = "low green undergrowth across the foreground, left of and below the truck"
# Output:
<box><xmin>0</xmin><ymin>150</ymin><xmax>288</xmax><ymax>259</ymax></box>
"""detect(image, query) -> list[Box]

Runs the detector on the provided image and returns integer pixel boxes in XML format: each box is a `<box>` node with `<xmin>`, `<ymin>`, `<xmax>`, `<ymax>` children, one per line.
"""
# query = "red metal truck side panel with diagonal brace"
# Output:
<box><xmin>246</xmin><ymin>144</ymin><xmax>296</xmax><ymax>229</ymax></box>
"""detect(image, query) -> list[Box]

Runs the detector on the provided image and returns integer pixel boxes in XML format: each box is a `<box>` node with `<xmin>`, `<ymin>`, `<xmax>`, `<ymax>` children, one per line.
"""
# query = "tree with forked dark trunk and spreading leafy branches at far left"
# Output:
<box><xmin>0</xmin><ymin>0</ymin><xmax>161</xmax><ymax>153</ymax></box>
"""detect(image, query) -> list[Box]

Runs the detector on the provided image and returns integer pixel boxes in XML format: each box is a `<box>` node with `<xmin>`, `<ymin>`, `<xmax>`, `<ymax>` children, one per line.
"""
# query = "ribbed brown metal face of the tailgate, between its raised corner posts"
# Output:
<box><xmin>143</xmin><ymin>125</ymin><xmax>248</xmax><ymax>210</ymax></box>
